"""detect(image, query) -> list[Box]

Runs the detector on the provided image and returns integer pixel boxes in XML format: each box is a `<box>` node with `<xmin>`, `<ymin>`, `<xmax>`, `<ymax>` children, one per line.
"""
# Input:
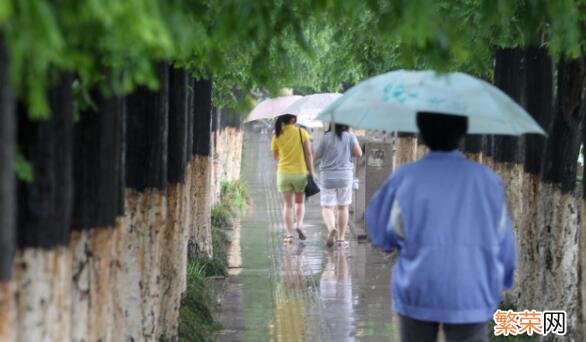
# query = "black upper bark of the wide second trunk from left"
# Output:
<box><xmin>18</xmin><ymin>75</ymin><xmax>73</xmax><ymax>248</ymax></box>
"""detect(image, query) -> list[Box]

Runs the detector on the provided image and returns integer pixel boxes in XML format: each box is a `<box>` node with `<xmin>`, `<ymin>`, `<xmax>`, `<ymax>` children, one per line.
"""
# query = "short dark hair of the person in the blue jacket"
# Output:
<box><xmin>417</xmin><ymin>112</ymin><xmax>468</xmax><ymax>151</ymax></box>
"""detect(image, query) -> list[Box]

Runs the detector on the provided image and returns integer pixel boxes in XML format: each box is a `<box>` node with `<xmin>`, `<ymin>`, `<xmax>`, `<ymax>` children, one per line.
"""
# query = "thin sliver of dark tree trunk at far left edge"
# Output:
<box><xmin>0</xmin><ymin>35</ymin><xmax>16</xmax><ymax>341</ymax></box>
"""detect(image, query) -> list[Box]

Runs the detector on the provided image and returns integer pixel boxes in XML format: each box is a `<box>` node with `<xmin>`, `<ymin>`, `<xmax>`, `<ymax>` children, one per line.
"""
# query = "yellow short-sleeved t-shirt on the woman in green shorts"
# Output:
<box><xmin>271</xmin><ymin>125</ymin><xmax>309</xmax><ymax>173</ymax></box>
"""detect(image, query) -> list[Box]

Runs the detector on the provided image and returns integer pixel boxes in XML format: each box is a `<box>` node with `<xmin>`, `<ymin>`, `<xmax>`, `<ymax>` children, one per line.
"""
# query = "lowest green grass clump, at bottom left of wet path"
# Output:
<box><xmin>179</xmin><ymin>260</ymin><xmax>220</xmax><ymax>341</ymax></box>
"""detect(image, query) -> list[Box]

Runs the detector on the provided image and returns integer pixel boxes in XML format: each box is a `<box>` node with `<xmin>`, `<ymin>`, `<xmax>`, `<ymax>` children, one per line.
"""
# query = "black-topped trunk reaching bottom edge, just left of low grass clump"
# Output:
<box><xmin>159</xmin><ymin>67</ymin><xmax>192</xmax><ymax>340</ymax></box>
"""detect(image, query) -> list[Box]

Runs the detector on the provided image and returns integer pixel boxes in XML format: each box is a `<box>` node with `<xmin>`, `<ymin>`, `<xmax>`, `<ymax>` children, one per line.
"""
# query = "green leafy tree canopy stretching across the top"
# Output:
<box><xmin>0</xmin><ymin>0</ymin><xmax>586</xmax><ymax>118</ymax></box>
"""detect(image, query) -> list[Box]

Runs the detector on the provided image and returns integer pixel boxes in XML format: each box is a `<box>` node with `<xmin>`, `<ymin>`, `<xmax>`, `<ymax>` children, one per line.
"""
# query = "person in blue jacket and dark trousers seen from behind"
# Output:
<box><xmin>366</xmin><ymin>113</ymin><xmax>516</xmax><ymax>341</ymax></box>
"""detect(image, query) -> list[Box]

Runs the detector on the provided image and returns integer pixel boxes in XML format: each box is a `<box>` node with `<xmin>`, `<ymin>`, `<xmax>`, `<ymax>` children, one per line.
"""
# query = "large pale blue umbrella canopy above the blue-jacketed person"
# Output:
<box><xmin>317</xmin><ymin>70</ymin><xmax>545</xmax><ymax>135</ymax></box>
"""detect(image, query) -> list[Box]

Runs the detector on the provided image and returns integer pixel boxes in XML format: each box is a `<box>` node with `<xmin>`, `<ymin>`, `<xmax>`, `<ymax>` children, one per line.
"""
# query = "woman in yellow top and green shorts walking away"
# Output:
<box><xmin>271</xmin><ymin>114</ymin><xmax>313</xmax><ymax>243</ymax></box>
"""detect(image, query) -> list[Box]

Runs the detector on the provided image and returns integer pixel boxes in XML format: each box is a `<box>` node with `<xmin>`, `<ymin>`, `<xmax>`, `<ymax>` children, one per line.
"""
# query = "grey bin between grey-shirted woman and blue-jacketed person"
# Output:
<box><xmin>353</xmin><ymin>137</ymin><xmax>393</xmax><ymax>239</ymax></box>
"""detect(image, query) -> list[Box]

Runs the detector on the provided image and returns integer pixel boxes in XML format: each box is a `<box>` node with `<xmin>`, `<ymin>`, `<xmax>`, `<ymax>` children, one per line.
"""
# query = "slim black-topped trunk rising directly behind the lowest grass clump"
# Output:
<box><xmin>188</xmin><ymin>79</ymin><xmax>213</xmax><ymax>257</ymax></box>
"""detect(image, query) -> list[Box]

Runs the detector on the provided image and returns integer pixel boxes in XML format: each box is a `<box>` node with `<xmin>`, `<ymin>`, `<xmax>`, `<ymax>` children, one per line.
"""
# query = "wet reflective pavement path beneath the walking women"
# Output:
<box><xmin>218</xmin><ymin>132</ymin><xmax>398</xmax><ymax>341</ymax></box>
